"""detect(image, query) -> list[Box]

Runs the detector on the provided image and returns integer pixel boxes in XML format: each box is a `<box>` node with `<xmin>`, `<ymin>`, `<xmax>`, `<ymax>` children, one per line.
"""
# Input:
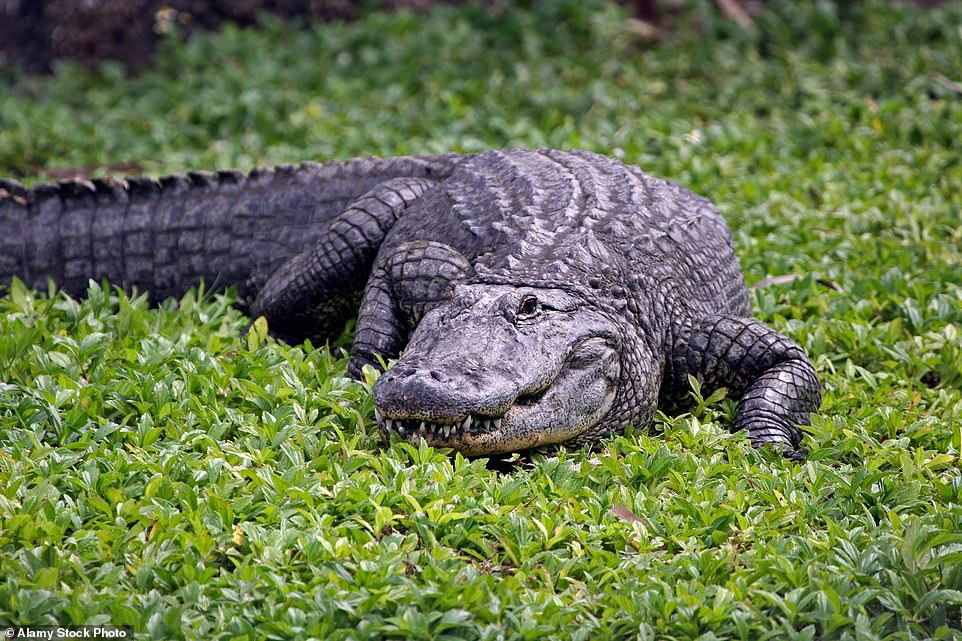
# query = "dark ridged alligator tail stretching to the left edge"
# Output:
<box><xmin>0</xmin><ymin>155</ymin><xmax>456</xmax><ymax>301</ymax></box>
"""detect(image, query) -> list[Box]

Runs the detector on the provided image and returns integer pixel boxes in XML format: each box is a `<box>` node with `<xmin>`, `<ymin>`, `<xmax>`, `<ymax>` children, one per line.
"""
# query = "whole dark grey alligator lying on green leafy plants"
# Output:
<box><xmin>0</xmin><ymin>149</ymin><xmax>821</xmax><ymax>458</ymax></box>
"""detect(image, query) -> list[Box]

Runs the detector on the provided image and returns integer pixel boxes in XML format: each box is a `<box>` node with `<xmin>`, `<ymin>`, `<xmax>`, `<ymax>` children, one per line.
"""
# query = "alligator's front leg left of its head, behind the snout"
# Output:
<box><xmin>348</xmin><ymin>240</ymin><xmax>473</xmax><ymax>378</ymax></box>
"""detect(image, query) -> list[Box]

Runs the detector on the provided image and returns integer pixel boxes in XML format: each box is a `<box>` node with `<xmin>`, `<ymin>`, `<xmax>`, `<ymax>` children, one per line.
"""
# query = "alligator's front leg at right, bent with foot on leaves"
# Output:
<box><xmin>661</xmin><ymin>316</ymin><xmax>821</xmax><ymax>458</ymax></box>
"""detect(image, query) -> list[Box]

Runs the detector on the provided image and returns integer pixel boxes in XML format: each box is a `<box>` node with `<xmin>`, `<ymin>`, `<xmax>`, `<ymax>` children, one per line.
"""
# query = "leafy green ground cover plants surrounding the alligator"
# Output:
<box><xmin>0</xmin><ymin>0</ymin><xmax>962</xmax><ymax>640</ymax></box>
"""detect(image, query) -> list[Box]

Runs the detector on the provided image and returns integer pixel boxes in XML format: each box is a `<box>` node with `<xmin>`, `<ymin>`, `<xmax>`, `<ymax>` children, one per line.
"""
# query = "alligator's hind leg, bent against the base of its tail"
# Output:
<box><xmin>251</xmin><ymin>178</ymin><xmax>436</xmax><ymax>342</ymax></box>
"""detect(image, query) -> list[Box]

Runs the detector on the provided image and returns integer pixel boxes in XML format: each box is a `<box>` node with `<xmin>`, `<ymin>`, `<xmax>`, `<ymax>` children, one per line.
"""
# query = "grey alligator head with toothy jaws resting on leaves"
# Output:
<box><xmin>374</xmin><ymin>284</ymin><xmax>621</xmax><ymax>456</ymax></box>
